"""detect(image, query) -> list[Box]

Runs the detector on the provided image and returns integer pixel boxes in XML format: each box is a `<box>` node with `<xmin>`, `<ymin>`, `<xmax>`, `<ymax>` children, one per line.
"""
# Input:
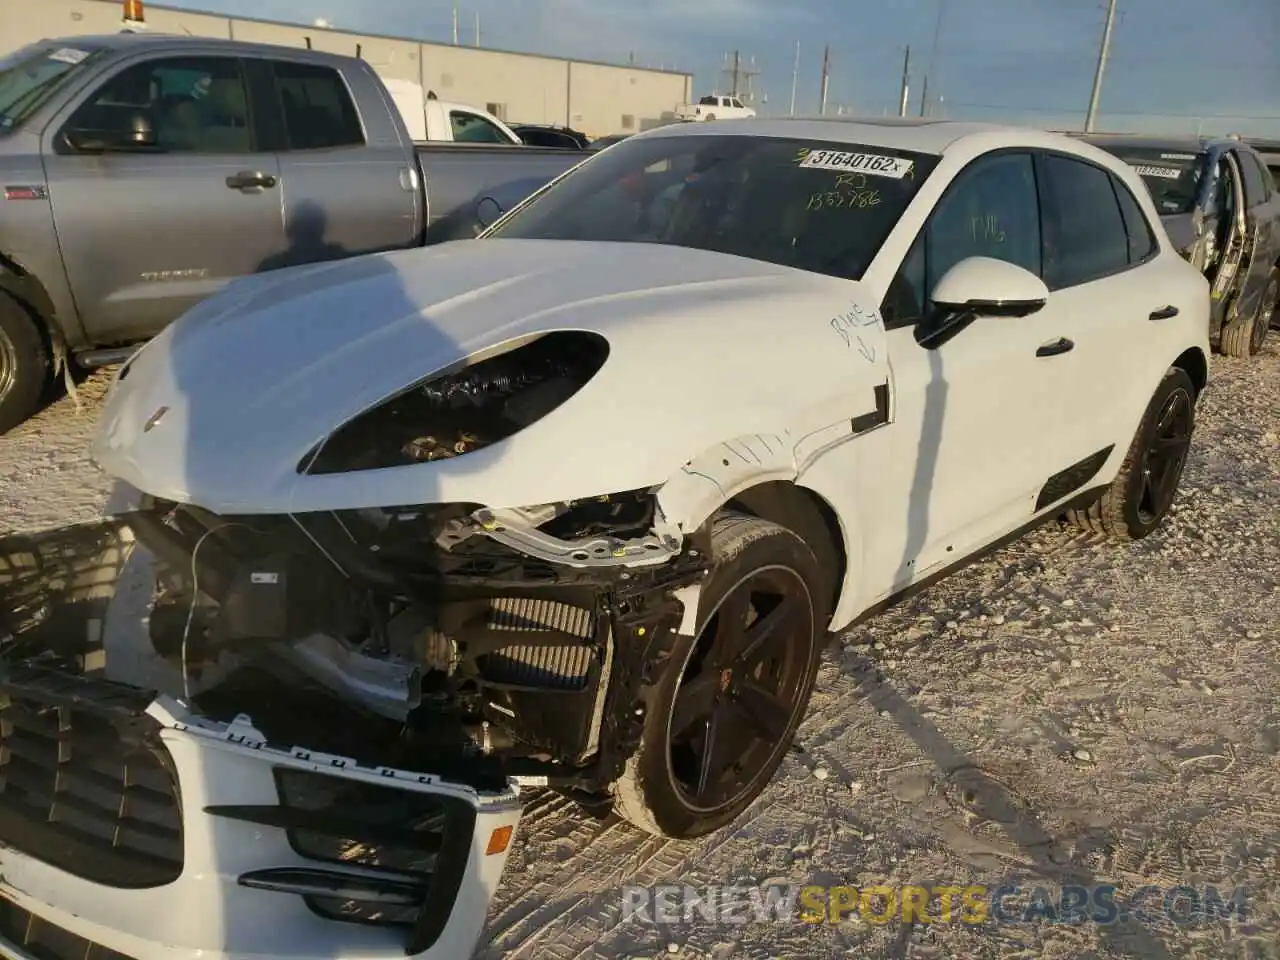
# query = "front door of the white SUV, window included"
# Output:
<box><xmin>859</xmin><ymin>151</ymin><xmax>1075</xmax><ymax>602</ymax></box>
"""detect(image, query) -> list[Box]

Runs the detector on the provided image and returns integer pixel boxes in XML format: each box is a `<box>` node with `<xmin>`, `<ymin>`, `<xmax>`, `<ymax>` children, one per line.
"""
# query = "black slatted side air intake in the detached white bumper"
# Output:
<box><xmin>206</xmin><ymin>768</ymin><xmax>475</xmax><ymax>954</ymax></box>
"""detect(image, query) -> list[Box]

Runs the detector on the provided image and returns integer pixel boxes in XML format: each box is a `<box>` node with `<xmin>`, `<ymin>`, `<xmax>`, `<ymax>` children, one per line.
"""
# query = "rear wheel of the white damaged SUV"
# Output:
<box><xmin>1066</xmin><ymin>367</ymin><xmax>1196</xmax><ymax>540</ymax></box>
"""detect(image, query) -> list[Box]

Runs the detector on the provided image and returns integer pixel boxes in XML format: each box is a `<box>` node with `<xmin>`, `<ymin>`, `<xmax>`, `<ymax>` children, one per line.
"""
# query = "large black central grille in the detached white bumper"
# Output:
<box><xmin>0</xmin><ymin>681</ymin><xmax>183</xmax><ymax>888</ymax></box>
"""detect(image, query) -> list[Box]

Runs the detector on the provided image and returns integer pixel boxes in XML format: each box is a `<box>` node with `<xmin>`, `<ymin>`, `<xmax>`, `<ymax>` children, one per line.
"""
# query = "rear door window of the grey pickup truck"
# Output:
<box><xmin>271</xmin><ymin>60</ymin><xmax>365</xmax><ymax>150</ymax></box>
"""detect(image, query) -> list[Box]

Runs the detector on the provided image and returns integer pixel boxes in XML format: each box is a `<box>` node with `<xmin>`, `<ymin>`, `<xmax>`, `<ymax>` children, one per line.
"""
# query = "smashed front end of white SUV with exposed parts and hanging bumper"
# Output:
<box><xmin>0</xmin><ymin>492</ymin><xmax>709</xmax><ymax>957</ymax></box>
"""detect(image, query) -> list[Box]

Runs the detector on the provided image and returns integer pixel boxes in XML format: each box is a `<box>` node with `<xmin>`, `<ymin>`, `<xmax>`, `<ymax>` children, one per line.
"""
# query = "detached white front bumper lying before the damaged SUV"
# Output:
<box><xmin>0</xmin><ymin>675</ymin><xmax>520</xmax><ymax>960</ymax></box>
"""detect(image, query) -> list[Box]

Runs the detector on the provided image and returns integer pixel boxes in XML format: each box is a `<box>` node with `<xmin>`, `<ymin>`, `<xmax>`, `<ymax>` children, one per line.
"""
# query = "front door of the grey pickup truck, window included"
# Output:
<box><xmin>42</xmin><ymin>55</ymin><xmax>285</xmax><ymax>346</ymax></box>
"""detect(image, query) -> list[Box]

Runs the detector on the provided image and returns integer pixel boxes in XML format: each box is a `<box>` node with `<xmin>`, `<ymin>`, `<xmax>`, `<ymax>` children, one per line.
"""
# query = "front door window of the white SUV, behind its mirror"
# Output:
<box><xmin>884</xmin><ymin>154</ymin><xmax>1042</xmax><ymax>325</ymax></box>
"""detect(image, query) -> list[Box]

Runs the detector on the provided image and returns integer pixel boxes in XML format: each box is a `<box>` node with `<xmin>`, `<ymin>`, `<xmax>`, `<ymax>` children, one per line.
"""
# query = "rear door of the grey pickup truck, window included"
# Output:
<box><xmin>248</xmin><ymin>56</ymin><xmax>424</xmax><ymax>266</ymax></box>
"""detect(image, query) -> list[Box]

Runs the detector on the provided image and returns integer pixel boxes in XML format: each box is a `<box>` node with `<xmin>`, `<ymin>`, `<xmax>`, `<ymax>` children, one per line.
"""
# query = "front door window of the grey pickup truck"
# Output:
<box><xmin>65</xmin><ymin>56</ymin><xmax>253</xmax><ymax>154</ymax></box>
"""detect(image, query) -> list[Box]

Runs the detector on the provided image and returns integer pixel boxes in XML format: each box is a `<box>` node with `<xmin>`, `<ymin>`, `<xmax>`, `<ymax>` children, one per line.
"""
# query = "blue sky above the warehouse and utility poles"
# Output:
<box><xmin>164</xmin><ymin>0</ymin><xmax>1280</xmax><ymax>137</ymax></box>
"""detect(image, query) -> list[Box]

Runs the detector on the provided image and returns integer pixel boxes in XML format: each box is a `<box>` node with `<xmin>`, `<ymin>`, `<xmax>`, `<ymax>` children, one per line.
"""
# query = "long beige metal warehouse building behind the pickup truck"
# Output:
<box><xmin>0</xmin><ymin>0</ymin><xmax>692</xmax><ymax>137</ymax></box>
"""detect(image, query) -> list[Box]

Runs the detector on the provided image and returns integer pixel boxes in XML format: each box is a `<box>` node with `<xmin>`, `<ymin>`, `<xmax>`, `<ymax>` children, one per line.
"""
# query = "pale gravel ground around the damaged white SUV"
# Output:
<box><xmin>0</xmin><ymin>340</ymin><xmax>1280</xmax><ymax>960</ymax></box>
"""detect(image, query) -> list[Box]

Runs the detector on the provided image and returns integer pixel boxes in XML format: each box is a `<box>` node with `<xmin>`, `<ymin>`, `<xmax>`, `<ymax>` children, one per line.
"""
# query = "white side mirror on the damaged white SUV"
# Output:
<box><xmin>916</xmin><ymin>257</ymin><xmax>1048</xmax><ymax>349</ymax></box>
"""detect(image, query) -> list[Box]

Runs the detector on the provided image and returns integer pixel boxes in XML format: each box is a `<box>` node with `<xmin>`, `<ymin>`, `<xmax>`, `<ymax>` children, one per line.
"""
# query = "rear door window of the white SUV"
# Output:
<box><xmin>1044</xmin><ymin>155</ymin><xmax>1129</xmax><ymax>291</ymax></box>
